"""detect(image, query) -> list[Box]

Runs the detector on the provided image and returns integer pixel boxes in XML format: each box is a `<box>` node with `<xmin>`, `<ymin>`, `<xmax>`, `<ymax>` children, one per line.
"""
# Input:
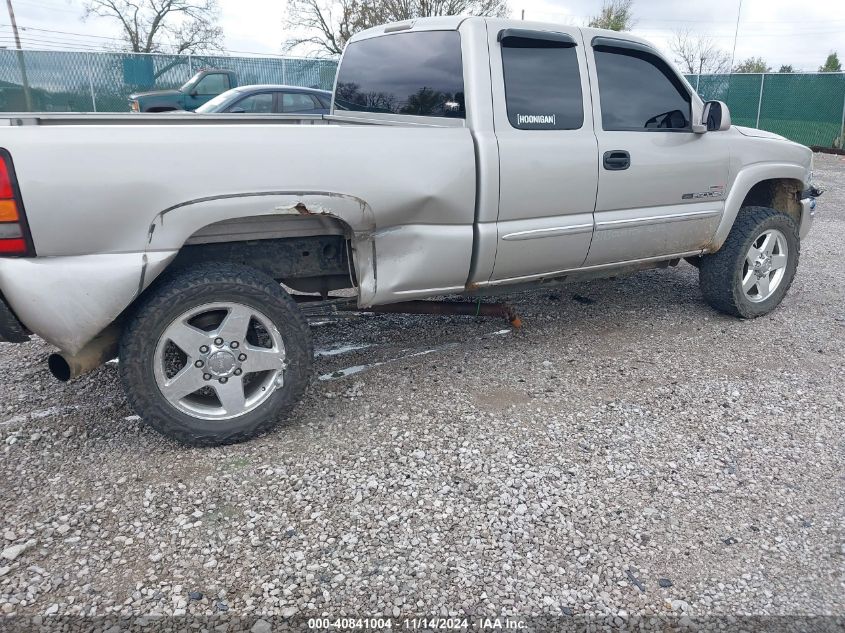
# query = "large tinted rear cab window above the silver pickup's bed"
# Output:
<box><xmin>335</xmin><ymin>31</ymin><xmax>466</xmax><ymax>118</ymax></box>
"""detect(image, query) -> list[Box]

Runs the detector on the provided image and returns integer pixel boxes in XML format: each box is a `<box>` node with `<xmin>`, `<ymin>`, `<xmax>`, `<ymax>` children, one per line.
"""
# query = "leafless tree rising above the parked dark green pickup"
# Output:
<box><xmin>85</xmin><ymin>0</ymin><xmax>223</xmax><ymax>53</ymax></box>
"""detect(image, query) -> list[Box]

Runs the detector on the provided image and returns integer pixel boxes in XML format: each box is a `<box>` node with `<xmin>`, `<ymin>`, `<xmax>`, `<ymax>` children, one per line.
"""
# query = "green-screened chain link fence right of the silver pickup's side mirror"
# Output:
<box><xmin>686</xmin><ymin>73</ymin><xmax>845</xmax><ymax>149</ymax></box>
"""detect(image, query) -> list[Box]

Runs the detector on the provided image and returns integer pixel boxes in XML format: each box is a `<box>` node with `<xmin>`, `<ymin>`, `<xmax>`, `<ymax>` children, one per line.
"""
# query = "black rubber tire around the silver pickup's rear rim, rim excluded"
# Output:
<box><xmin>120</xmin><ymin>262</ymin><xmax>314</xmax><ymax>446</ymax></box>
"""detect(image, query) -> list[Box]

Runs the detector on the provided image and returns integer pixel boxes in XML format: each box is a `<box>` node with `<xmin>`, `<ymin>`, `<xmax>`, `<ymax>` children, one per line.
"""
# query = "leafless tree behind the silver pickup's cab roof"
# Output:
<box><xmin>283</xmin><ymin>0</ymin><xmax>510</xmax><ymax>56</ymax></box>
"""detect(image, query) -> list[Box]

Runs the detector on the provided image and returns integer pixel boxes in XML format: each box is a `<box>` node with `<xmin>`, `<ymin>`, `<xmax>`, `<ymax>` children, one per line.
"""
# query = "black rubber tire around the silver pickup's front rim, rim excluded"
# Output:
<box><xmin>698</xmin><ymin>207</ymin><xmax>800</xmax><ymax>319</ymax></box>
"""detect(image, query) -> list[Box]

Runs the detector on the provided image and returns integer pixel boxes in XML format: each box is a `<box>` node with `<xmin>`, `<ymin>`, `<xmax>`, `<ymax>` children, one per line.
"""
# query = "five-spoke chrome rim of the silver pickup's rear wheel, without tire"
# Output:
<box><xmin>153</xmin><ymin>302</ymin><xmax>287</xmax><ymax>420</ymax></box>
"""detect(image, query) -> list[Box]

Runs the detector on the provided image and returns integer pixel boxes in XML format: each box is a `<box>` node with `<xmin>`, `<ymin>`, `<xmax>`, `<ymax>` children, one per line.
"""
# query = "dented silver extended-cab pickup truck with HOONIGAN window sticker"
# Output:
<box><xmin>0</xmin><ymin>17</ymin><xmax>818</xmax><ymax>445</ymax></box>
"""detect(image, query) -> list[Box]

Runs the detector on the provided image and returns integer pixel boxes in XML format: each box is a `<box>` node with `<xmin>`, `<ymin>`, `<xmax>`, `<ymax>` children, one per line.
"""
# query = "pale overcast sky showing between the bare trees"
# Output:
<box><xmin>0</xmin><ymin>0</ymin><xmax>845</xmax><ymax>70</ymax></box>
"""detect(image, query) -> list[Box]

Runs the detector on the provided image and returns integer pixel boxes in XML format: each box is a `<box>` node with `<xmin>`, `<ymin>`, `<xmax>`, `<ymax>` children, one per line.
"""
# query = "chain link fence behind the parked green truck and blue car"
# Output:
<box><xmin>0</xmin><ymin>49</ymin><xmax>337</xmax><ymax>112</ymax></box>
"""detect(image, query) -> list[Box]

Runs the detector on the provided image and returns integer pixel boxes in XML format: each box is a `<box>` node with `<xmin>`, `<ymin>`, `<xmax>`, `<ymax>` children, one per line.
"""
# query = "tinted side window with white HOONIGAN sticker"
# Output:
<box><xmin>502</xmin><ymin>37</ymin><xmax>584</xmax><ymax>130</ymax></box>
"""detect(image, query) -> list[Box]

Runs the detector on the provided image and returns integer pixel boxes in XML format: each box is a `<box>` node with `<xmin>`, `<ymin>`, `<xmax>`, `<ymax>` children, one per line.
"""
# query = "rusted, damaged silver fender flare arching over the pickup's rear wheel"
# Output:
<box><xmin>142</xmin><ymin>191</ymin><xmax>376</xmax><ymax>306</ymax></box>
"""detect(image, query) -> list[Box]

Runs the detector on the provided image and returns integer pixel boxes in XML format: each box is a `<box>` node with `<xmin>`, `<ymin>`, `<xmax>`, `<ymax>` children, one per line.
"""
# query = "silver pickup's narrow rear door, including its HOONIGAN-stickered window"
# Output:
<box><xmin>488</xmin><ymin>21</ymin><xmax>598</xmax><ymax>281</ymax></box>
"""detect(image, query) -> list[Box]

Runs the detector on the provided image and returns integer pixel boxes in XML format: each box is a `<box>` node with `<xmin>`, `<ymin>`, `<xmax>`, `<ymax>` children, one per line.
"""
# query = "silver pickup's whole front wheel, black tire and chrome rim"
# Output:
<box><xmin>698</xmin><ymin>207</ymin><xmax>800</xmax><ymax>319</ymax></box>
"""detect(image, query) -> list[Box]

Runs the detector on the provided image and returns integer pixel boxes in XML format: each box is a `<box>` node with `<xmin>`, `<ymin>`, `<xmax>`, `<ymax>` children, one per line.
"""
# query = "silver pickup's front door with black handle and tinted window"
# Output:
<box><xmin>586</xmin><ymin>37</ymin><xmax>730</xmax><ymax>266</ymax></box>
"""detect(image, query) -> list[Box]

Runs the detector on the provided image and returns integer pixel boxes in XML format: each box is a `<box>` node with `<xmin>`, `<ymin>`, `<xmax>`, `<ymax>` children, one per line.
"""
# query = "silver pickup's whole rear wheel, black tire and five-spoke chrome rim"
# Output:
<box><xmin>120</xmin><ymin>263</ymin><xmax>313</xmax><ymax>446</ymax></box>
